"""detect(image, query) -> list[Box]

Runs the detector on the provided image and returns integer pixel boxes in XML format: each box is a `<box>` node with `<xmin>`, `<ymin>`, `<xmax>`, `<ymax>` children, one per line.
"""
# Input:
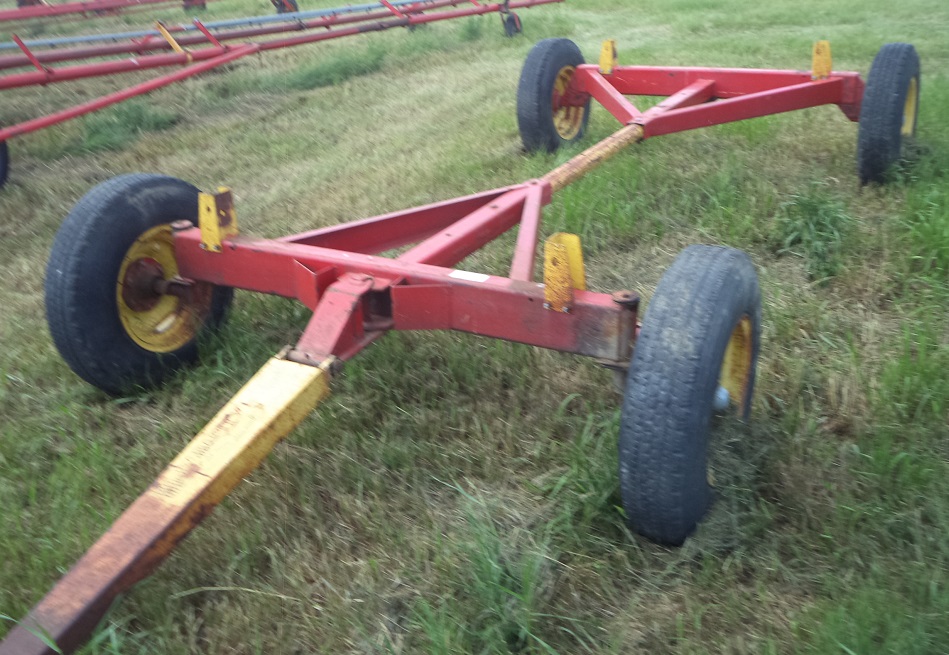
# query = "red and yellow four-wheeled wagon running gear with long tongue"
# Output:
<box><xmin>0</xmin><ymin>39</ymin><xmax>919</xmax><ymax>655</ymax></box>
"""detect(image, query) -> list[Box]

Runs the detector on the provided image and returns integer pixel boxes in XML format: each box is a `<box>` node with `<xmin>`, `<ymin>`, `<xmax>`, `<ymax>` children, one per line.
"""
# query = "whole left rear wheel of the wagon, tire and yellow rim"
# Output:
<box><xmin>517</xmin><ymin>39</ymin><xmax>590</xmax><ymax>152</ymax></box>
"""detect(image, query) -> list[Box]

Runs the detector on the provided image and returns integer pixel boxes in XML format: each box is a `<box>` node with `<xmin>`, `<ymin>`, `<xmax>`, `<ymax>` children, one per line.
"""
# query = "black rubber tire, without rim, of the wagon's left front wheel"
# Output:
<box><xmin>45</xmin><ymin>174</ymin><xmax>233</xmax><ymax>395</ymax></box>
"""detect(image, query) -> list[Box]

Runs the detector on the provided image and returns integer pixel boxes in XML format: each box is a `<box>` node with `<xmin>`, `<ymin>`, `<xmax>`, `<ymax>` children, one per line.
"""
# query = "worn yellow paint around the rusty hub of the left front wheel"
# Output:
<box><xmin>115</xmin><ymin>224</ymin><xmax>212</xmax><ymax>353</ymax></box>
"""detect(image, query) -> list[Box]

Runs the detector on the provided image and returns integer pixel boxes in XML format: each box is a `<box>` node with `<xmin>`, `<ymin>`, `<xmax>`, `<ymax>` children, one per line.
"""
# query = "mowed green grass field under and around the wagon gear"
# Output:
<box><xmin>0</xmin><ymin>0</ymin><xmax>949</xmax><ymax>655</ymax></box>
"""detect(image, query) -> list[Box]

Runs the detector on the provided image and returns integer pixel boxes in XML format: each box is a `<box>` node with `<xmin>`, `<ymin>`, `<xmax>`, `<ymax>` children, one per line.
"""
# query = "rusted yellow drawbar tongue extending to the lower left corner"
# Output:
<box><xmin>0</xmin><ymin>358</ymin><xmax>330</xmax><ymax>655</ymax></box>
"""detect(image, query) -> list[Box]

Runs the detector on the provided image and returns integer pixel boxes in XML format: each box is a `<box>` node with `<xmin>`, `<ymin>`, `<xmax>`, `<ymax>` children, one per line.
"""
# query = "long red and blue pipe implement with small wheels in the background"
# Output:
<box><xmin>0</xmin><ymin>0</ymin><xmax>563</xmax><ymax>186</ymax></box>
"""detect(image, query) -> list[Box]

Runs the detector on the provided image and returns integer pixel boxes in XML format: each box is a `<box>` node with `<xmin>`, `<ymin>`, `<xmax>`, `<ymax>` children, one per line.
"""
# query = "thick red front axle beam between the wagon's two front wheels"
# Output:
<box><xmin>175</xmin><ymin>228</ymin><xmax>629</xmax><ymax>361</ymax></box>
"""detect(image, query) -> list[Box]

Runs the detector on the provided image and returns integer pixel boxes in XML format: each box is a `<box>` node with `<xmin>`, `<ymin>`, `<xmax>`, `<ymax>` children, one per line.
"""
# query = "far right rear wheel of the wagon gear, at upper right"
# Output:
<box><xmin>857</xmin><ymin>43</ymin><xmax>919</xmax><ymax>184</ymax></box>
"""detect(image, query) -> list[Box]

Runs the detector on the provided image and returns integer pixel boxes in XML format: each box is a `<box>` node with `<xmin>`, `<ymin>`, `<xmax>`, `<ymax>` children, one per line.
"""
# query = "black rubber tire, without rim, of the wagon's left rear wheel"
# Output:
<box><xmin>517</xmin><ymin>39</ymin><xmax>590</xmax><ymax>153</ymax></box>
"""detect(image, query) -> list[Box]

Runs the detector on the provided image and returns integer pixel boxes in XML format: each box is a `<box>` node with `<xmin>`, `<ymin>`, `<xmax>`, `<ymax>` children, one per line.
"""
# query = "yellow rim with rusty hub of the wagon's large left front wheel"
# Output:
<box><xmin>115</xmin><ymin>225</ymin><xmax>212</xmax><ymax>353</ymax></box>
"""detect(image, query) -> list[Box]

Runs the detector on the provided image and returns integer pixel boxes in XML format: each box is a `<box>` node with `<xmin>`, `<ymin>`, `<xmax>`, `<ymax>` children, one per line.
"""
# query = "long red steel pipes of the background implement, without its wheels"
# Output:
<box><xmin>0</xmin><ymin>0</ymin><xmax>563</xmax><ymax>142</ymax></box>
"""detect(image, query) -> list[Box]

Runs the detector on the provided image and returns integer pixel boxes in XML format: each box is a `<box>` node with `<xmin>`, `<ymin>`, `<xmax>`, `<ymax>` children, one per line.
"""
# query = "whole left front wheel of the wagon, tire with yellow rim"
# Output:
<box><xmin>45</xmin><ymin>174</ymin><xmax>233</xmax><ymax>395</ymax></box>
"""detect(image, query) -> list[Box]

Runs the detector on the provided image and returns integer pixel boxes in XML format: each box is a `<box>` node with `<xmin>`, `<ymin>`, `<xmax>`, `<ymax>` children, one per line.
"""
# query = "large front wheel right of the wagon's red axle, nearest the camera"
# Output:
<box><xmin>619</xmin><ymin>246</ymin><xmax>761</xmax><ymax>546</ymax></box>
